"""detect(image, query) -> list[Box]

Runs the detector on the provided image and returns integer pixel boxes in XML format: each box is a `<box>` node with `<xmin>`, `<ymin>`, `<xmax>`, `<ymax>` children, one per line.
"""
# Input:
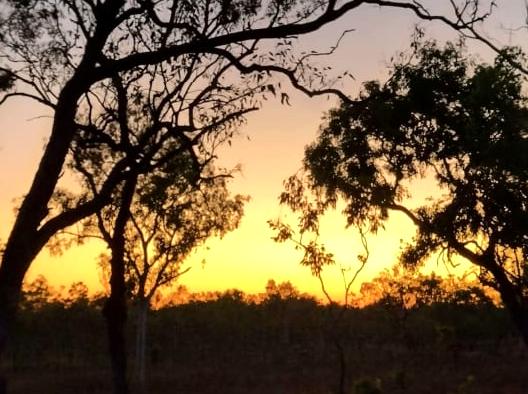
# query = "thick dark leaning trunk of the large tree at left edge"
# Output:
<box><xmin>0</xmin><ymin>6</ymin><xmax>124</xmax><ymax>394</ymax></box>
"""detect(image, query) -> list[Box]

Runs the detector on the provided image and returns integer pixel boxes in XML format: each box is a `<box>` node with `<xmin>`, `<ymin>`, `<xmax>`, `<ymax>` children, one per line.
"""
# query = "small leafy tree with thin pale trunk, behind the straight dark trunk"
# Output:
<box><xmin>97</xmin><ymin>160</ymin><xmax>246</xmax><ymax>391</ymax></box>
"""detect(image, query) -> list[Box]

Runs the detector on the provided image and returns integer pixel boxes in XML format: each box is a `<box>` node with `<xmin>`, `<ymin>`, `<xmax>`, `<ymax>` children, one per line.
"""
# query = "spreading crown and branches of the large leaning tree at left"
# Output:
<box><xmin>0</xmin><ymin>0</ymin><xmax>502</xmax><ymax>278</ymax></box>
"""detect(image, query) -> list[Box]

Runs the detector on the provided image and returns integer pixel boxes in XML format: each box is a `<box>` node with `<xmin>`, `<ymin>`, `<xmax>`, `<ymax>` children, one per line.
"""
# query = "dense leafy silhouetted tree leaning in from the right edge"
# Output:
<box><xmin>289</xmin><ymin>41</ymin><xmax>528</xmax><ymax>344</ymax></box>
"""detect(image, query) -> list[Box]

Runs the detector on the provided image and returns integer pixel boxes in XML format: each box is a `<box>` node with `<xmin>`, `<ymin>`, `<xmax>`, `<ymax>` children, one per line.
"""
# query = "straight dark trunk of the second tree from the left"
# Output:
<box><xmin>103</xmin><ymin>174</ymin><xmax>137</xmax><ymax>394</ymax></box>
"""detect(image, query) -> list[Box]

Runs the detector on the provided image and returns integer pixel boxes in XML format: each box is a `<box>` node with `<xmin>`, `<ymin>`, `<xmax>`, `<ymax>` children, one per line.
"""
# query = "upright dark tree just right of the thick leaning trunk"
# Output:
<box><xmin>55</xmin><ymin>56</ymin><xmax>250</xmax><ymax>393</ymax></box>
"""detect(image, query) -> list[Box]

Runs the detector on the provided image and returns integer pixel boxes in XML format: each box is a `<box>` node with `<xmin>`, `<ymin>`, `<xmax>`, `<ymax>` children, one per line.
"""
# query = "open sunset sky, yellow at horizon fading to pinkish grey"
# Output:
<box><xmin>0</xmin><ymin>0</ymin><xmax>527</xmax><ymax>298</ymax></box>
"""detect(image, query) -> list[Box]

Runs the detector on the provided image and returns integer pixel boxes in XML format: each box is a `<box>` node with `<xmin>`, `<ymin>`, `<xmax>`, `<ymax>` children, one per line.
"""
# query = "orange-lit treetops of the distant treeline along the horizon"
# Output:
<box><xmin>14</xmin><ymin>266</ymin><xmax>502</xmax><ymax>311</ymax></box>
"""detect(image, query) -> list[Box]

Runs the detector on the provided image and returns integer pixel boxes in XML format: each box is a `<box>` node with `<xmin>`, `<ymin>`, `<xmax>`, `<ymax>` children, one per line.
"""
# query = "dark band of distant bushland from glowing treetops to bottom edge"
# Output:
<box><xmin>5</xmin><ymin>271</ymin><xmax>528</xmax><ymax>394</ymax></box>
